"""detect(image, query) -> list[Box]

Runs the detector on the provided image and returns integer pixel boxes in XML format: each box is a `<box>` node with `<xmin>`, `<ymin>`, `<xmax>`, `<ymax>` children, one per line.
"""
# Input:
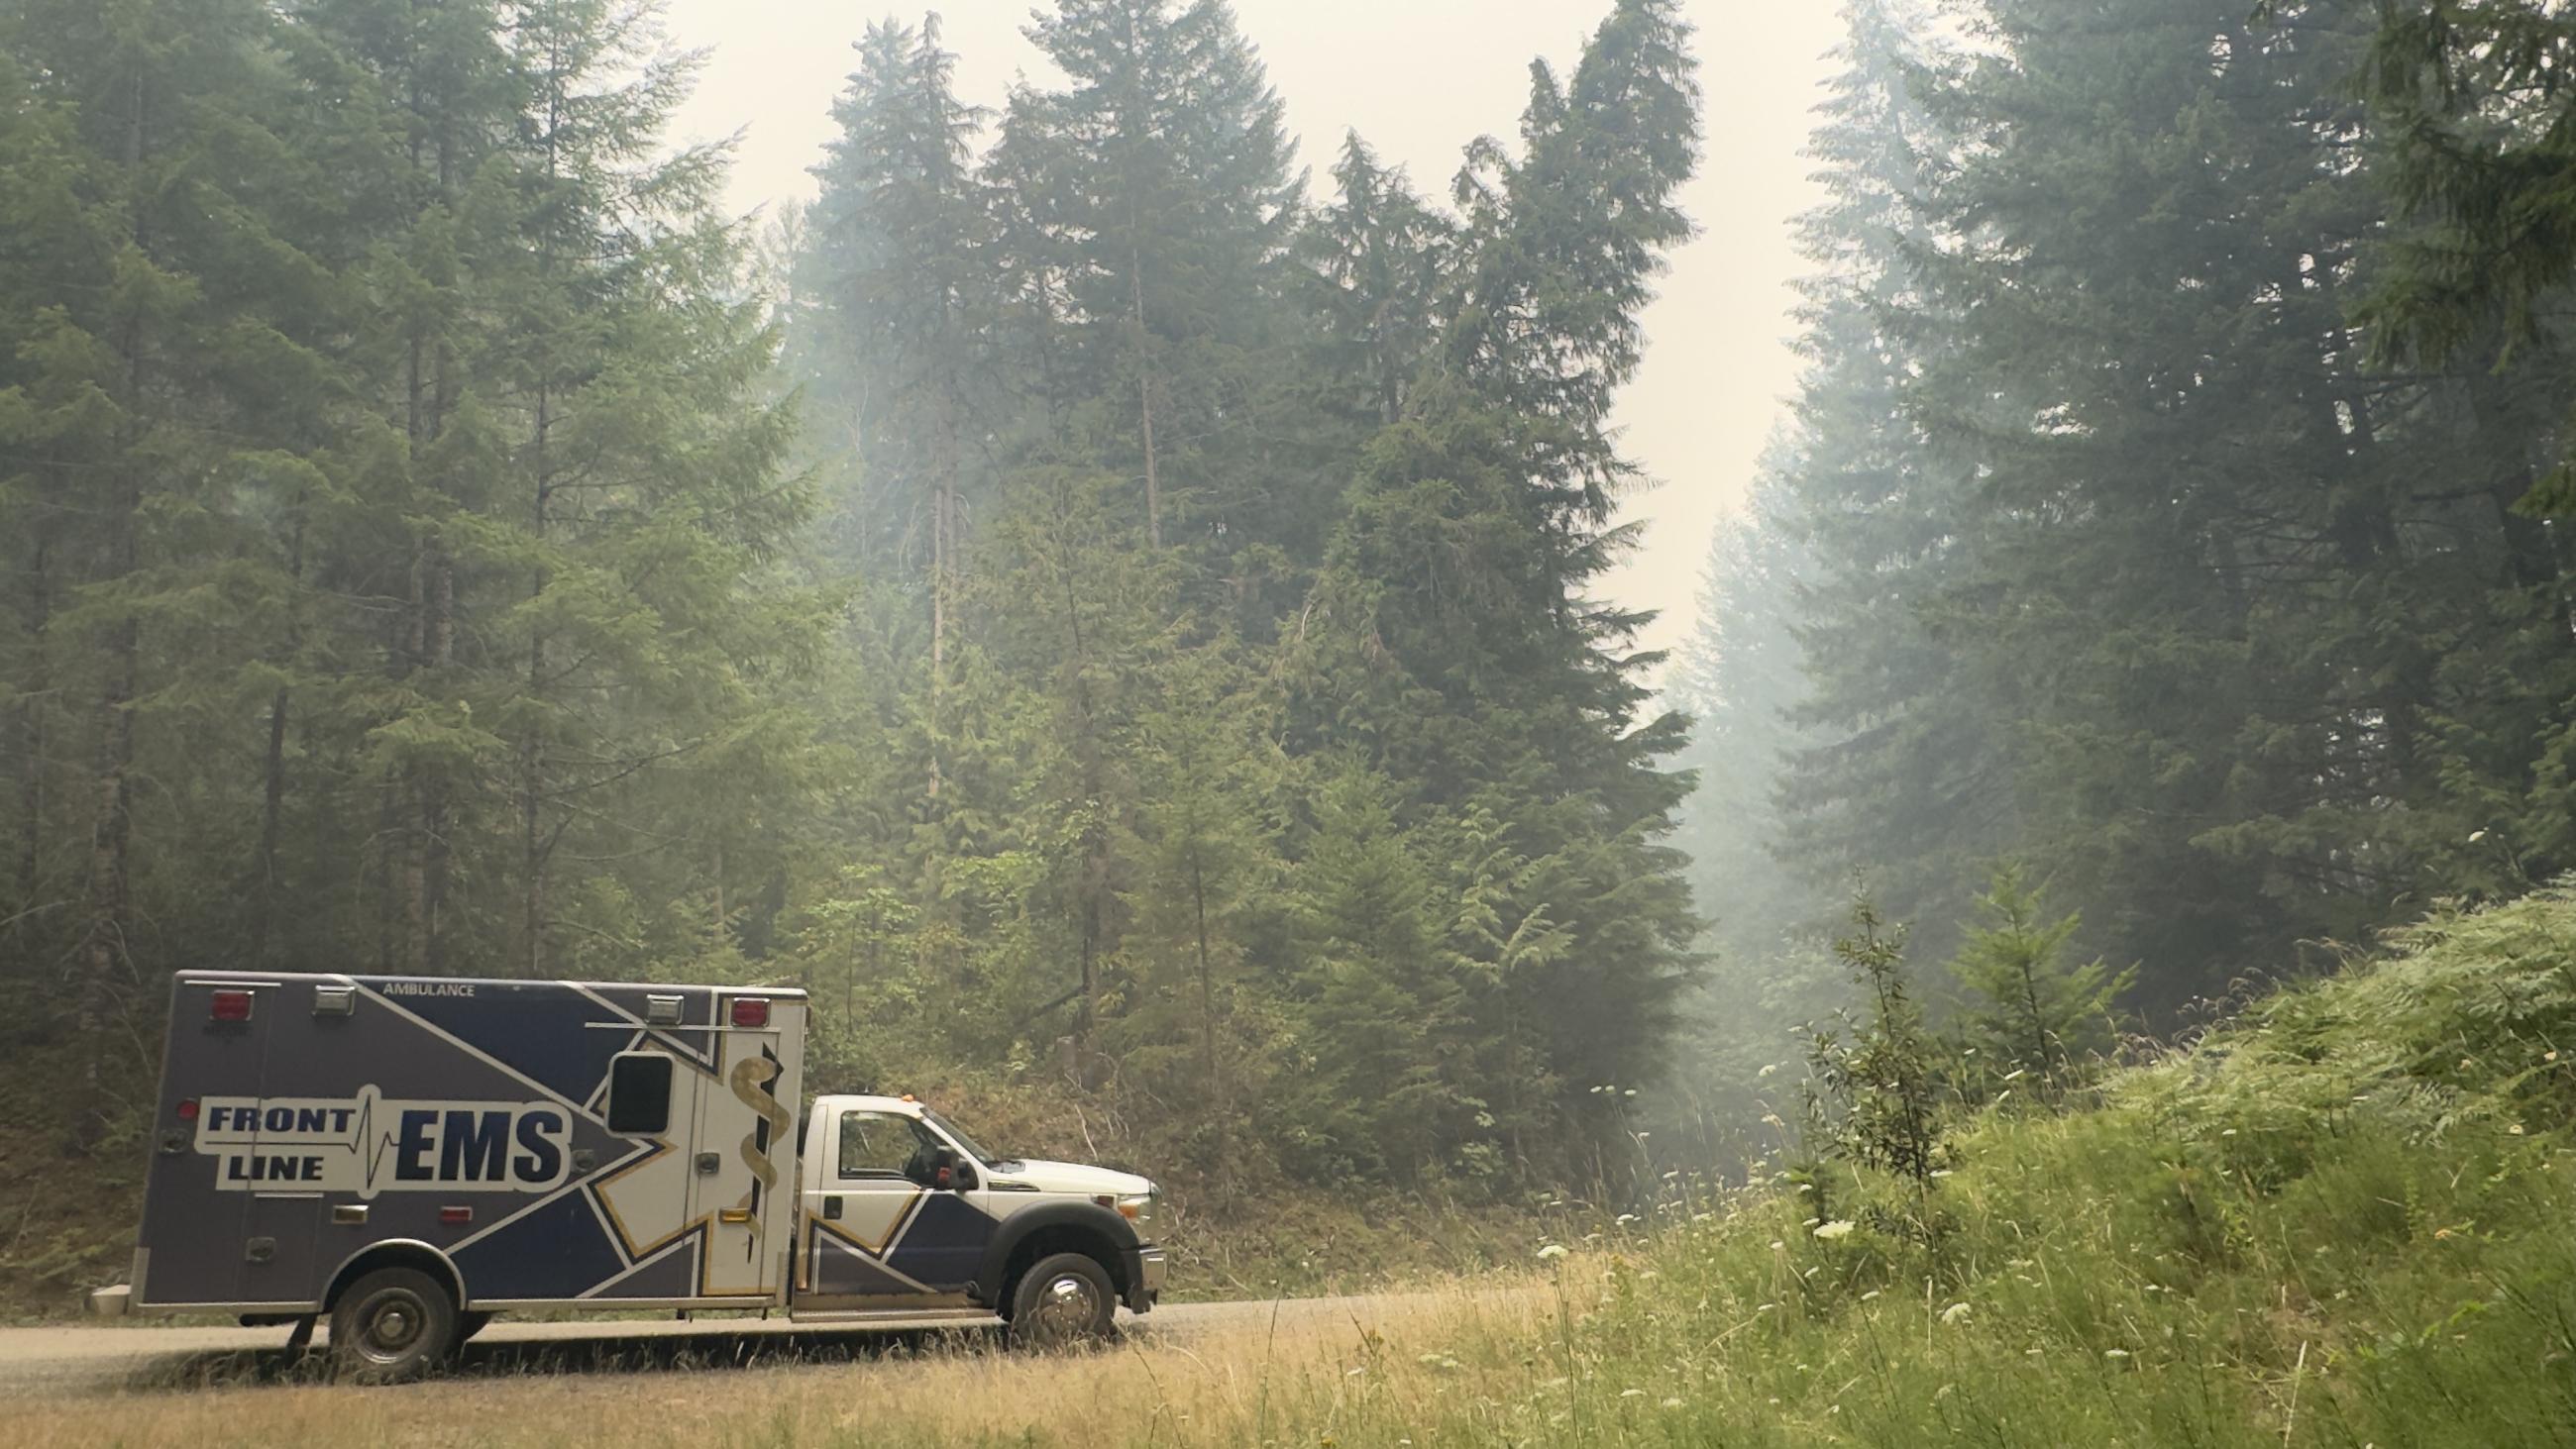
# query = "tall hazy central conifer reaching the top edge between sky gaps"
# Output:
<box><xmin>1002</xmin><ymin>0</ymin><xmax>1311</xmax><ymax>564</ymax></box>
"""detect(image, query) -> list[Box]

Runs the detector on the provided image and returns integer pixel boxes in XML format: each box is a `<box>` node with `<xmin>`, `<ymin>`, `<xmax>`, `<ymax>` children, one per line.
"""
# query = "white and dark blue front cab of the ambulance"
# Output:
<box><xmin>791</xmin><ymin>1096</ymin><xmax>1164</xmax><ymax>1338</ymax></box>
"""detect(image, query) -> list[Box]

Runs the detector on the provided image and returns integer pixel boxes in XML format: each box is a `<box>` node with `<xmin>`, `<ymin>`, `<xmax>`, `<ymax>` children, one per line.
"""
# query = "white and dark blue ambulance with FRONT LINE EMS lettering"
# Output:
<box><xmin>93</xmin><ymin>971</ymin><xmax>1164</xmax><ymax>1382</ymax></box>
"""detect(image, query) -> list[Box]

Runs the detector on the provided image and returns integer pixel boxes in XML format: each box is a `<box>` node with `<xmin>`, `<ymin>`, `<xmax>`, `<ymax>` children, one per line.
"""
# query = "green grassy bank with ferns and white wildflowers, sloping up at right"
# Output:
<box><xmin>1407</xmin><ymin>890</ymin><xmax>2576</xmax><ymax>1449</ymax></box>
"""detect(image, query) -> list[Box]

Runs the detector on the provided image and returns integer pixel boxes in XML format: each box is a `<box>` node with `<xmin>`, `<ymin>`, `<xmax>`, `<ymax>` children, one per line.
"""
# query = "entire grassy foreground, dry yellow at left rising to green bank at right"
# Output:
<box><xmin>16</xmin><ymin>890</ymin><xmax>2576</xmax><ymax>1449</ymax></box>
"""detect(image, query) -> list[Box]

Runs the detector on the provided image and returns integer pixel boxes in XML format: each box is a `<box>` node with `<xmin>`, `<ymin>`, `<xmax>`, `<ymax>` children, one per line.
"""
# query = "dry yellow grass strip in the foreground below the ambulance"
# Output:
<box><xmin>8</xmin><ymin>1279</ymin><xmax>1558</xmax><ymax>1449</ymax></box>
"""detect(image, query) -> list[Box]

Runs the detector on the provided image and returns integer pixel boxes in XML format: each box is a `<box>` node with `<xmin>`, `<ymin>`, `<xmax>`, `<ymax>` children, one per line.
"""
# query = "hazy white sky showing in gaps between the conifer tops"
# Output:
<box><xmin>654</xmin><ymin>0</ymin><xmax>1839</xmax><ymax>669</ymax></box>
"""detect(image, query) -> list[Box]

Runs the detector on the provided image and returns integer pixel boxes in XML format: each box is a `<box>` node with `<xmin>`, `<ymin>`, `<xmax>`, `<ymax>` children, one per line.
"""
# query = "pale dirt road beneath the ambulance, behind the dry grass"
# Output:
<box><xmin>0</xmin><ymin>1294</ymin><xmax>1430</xmax><ymax>1397</ymax></box>
